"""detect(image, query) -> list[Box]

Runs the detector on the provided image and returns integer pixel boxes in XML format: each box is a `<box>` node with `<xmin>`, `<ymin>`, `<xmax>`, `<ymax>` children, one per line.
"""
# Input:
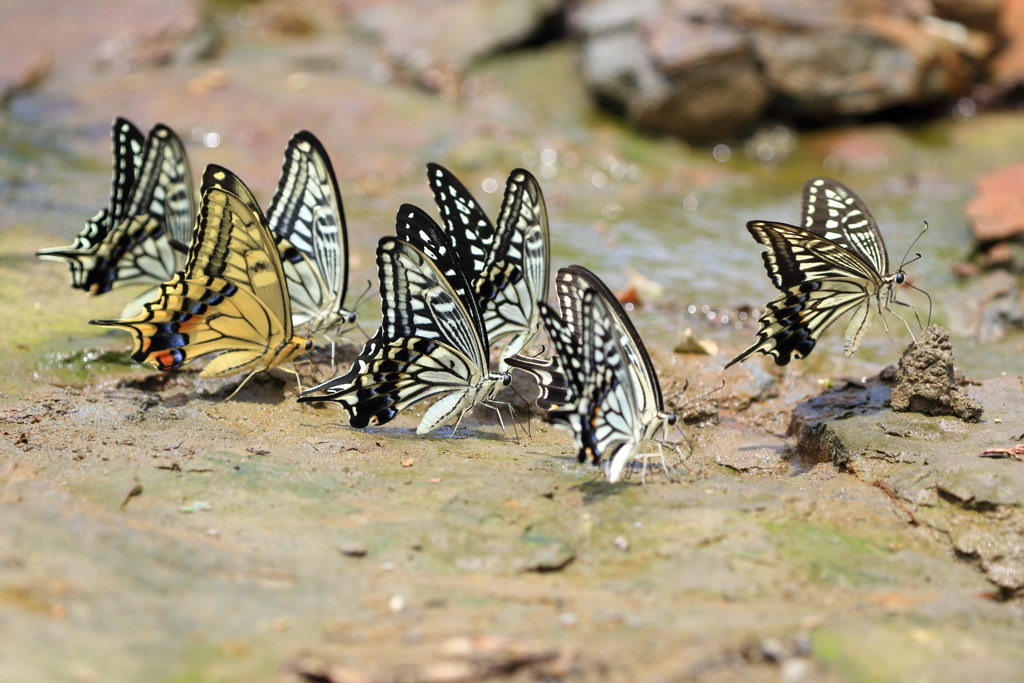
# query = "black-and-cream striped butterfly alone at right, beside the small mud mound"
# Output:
<box><xmin>726</xmin><ymin>178</ymin><xmax>916</xmax><ymax>368</ymax></box>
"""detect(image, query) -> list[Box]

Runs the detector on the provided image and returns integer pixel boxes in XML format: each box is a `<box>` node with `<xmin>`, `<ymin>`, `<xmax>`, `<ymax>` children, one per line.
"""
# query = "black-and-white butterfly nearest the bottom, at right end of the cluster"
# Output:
<box><xmin>508</xmin><ymin>265</ymin><xmax>678</xmax><ymax>481</ymax></box>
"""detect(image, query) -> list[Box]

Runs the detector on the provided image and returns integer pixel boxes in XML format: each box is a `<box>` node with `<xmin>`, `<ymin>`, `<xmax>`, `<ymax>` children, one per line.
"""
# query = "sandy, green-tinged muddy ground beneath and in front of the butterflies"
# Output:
<box><xmin>6</xmin><ymin>227</ymin><xmax>1024</xmax><ymax>682</ymax></box>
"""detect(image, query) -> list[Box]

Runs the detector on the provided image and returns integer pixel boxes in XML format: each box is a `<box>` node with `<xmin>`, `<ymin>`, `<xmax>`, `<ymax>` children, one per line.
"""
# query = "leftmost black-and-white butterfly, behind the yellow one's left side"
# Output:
<box><xmin>37</xmin><ymin>118</ymin><xmax>195</xmax><ymax>301</ymax></box>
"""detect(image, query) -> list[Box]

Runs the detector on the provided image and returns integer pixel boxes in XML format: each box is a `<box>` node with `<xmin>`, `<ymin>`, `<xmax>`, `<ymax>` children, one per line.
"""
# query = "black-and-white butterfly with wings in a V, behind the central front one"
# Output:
<box><xmin>427</xmin><ymin>164</ymin><xmax>551</xmax><ymax>370</ymax></box>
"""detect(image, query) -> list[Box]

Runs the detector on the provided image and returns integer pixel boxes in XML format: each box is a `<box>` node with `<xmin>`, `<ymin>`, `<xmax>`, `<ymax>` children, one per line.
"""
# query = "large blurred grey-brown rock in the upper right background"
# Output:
<box><xmin>569</xmin><ymin>0</ymin><xmax>994</xmax><ymax>140</ymax></box>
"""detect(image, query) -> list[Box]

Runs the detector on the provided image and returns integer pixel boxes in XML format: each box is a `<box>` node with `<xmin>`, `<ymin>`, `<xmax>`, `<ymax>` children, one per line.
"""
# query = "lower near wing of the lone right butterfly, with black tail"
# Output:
<box><xmin>726</xmin><ymin>221</ymin><xmax>894</xmax><ymax>368</ymax></box>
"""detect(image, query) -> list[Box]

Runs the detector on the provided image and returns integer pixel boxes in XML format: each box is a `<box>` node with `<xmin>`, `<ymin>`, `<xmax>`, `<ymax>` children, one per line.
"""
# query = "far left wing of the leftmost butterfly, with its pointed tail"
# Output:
<box><xmin>37</xmin><ymin>118</ymin><xmax>145</xmax><ymax>294</ymax></box>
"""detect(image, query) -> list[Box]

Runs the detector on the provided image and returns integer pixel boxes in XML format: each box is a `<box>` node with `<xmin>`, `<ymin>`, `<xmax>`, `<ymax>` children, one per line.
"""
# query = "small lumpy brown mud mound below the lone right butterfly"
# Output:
<box><xmin>892</xmin><ymin>325</ymin><xmax>983</xmax><ymax>422</ymax></box>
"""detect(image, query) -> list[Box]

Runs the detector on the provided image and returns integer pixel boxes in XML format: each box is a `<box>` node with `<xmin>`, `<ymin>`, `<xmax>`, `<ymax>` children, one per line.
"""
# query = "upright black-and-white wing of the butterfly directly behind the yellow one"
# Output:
<box><xmin>267</xmin><ymin>130</ymin><xmax>355</xmax><ymax>331</ymax></box>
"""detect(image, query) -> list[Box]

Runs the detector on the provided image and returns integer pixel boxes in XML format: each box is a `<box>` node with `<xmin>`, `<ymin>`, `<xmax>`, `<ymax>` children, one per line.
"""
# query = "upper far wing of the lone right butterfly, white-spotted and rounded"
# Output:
<box><xmin>801</xmin><ymin>178</ymin><xmax>889</xmax><ymax>275</ymax></box>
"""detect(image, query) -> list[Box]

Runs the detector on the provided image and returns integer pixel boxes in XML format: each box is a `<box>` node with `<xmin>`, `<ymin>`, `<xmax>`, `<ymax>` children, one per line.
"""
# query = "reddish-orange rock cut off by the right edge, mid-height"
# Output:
<box><xmin>965</xmin><ymin>164</ymin><xmax>1024</xmax><ymax>243</ymax></box>
